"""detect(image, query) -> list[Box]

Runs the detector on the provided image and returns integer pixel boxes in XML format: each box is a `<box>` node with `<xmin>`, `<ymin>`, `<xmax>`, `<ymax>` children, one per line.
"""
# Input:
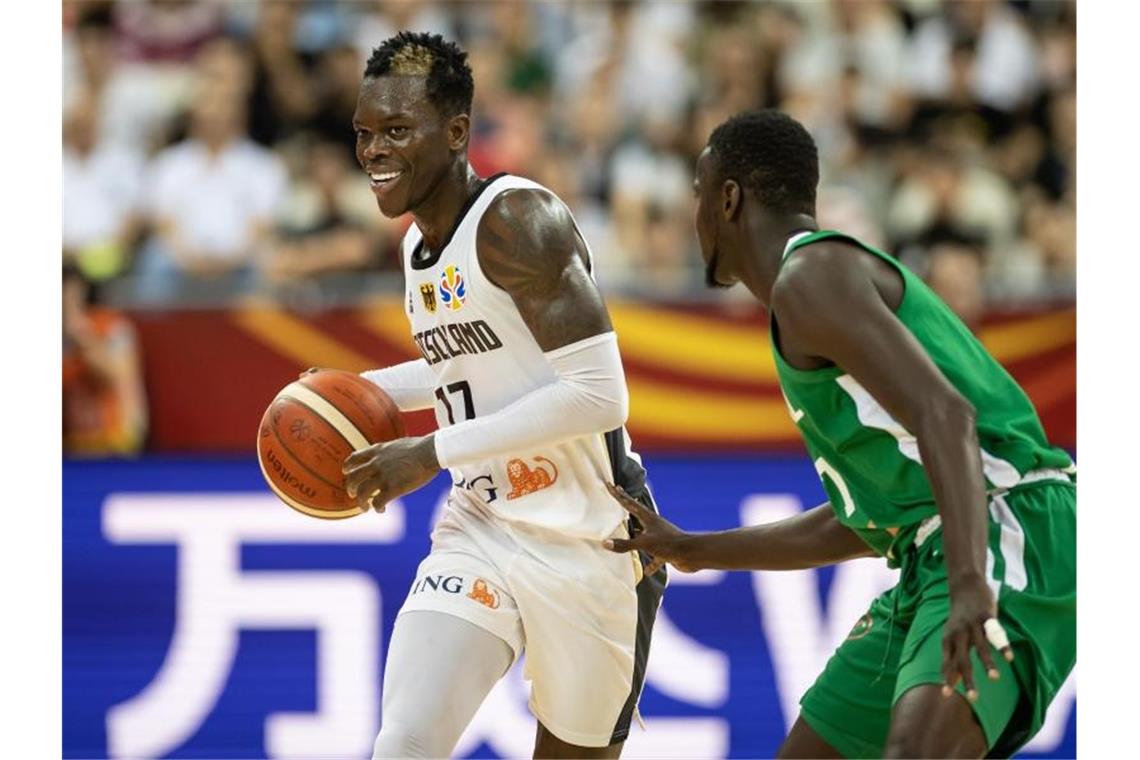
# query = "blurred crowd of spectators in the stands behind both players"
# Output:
<box><xmin>63</xmin><ymin>0</ymin><xmax>1076</xmax><ymax>451</ymax></box>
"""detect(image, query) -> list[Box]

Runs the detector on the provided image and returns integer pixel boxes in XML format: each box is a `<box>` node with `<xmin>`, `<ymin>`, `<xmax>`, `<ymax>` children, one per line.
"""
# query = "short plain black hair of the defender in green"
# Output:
<box><xmin>709</xmin><ymin>108</ymin><xmax>820</xmax><ymax>215</ymax></box>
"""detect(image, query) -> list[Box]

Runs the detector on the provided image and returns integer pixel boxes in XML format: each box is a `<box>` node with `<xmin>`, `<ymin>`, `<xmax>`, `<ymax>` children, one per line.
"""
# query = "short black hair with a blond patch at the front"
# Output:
<box><xmin>364</xmin><ymin>32</ymin><xmax>475</xmax><ymax>117</ymax></box>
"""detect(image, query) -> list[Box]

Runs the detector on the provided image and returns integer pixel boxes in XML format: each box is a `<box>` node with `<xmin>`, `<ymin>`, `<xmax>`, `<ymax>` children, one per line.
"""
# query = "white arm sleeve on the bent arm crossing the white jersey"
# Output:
<box><xmin>435</xmin><ymin>332</ymin><xmax>629</xmax><ymax>467</ymax></box>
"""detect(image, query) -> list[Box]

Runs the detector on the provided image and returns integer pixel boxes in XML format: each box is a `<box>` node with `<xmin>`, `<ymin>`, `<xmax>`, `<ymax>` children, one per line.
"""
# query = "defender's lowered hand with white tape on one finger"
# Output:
<box><xmin>942</xmin><ymin>578</ymin><xmax>1013</xmax><ymax>702</ymax></box>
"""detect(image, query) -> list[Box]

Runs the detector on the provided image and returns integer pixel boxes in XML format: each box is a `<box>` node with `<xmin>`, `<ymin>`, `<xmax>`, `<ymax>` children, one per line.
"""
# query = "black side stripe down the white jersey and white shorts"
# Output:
<box><xmin>605</xmin><ymin>427</ymin><xmax>668</xmax><ymax>744</ymax></box>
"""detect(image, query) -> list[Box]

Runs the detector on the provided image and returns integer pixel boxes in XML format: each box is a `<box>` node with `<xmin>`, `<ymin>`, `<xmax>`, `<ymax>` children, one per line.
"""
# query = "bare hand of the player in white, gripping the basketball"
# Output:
<box><xmin>343</xmin><ymin>435</ymin><xmax>439</xmax><ymax>512</ymax></box>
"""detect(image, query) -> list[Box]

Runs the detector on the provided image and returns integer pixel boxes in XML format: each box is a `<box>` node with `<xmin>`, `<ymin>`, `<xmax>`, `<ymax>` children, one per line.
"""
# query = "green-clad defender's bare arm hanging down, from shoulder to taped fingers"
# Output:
<box><xmin>772</xmin><ymin>245</ymin><xmax>1009</xmax><ymax>690</ymax></box>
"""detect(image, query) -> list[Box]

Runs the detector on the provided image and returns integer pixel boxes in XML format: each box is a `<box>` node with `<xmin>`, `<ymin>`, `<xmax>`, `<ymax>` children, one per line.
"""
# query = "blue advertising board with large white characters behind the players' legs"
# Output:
<box><xmin>63</xmin><ymin>457</ymin><xmax>1076</xmax><ymax>758</ymax></box>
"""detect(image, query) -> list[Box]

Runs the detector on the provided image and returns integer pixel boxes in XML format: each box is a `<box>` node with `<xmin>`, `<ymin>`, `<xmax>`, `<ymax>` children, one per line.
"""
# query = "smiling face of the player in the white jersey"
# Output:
<box><xmin>352</xmin><ymin>75</ymin><xmax>470</xmax><ymax>218</ymax></box>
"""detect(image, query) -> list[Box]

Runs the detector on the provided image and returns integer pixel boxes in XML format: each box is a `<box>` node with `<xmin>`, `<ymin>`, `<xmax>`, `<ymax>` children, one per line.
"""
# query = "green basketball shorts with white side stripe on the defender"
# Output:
<box><xmin>800</xmin><ymin>481</ymin><xmax>1076</xmax><ymax>758</ymax></box>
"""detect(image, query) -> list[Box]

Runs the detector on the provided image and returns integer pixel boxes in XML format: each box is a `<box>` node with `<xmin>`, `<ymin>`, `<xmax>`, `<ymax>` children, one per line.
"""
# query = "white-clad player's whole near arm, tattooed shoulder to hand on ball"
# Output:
<box><xmin>345</xmin><ymin>189</ymin><xmax>629</xmax><ymax>509</ymax></box>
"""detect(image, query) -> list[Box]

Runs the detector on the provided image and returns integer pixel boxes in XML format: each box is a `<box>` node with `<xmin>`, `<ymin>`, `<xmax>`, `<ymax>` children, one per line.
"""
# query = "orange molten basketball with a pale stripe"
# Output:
<box><xmin>258</xmin><ymin>369</ymin><xmax>404</xmax><ymax>520</ymax></box>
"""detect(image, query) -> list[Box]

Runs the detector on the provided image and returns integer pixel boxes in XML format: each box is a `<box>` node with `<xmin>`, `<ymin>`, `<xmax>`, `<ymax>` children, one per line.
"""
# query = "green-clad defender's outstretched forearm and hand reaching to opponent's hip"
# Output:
<box><xmin>604</xmin><ymin>485</ymin><xmax>874</xmax><ymax>573</ymax></box>
